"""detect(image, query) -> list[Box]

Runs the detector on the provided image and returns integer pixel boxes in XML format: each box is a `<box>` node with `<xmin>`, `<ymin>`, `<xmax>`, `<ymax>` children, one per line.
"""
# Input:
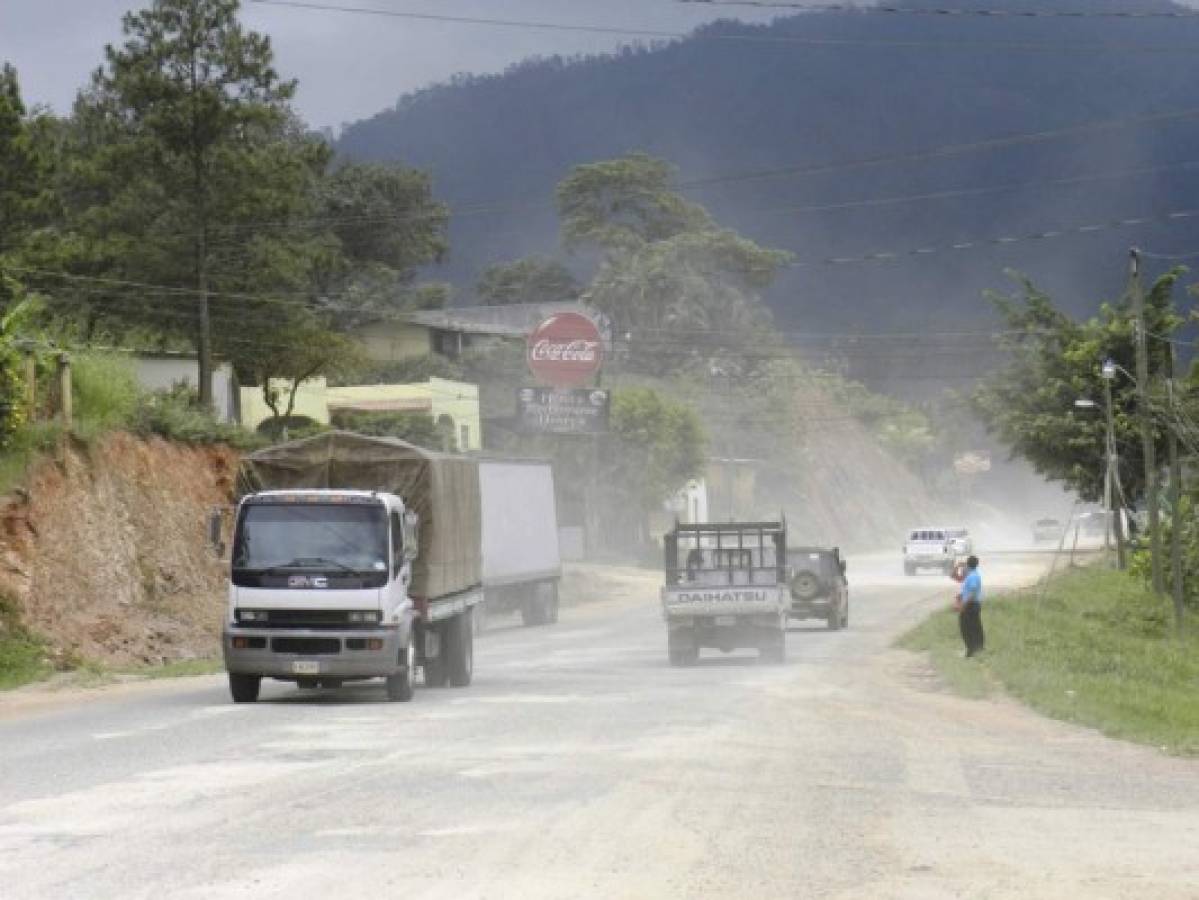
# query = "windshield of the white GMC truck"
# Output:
<box><xmin>233</xmin><ymin>503</ymin><xmax>387</xmax><ymax>572</ymax></box>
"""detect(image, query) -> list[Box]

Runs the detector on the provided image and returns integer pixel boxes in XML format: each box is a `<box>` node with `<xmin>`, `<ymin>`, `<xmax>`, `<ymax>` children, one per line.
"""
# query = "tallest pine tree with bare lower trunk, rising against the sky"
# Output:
<box><xmin>83</xmin><ymin>0</ymin><xmax>302</xmax><ymax>405</ymax></box>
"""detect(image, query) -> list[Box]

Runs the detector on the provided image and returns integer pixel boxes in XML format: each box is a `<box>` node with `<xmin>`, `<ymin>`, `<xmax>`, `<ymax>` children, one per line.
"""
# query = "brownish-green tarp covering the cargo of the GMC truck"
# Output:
<box><xmin>239</xmin><ymin>431</ymin><xmax>483</xmax><ymax>598</ymax></box>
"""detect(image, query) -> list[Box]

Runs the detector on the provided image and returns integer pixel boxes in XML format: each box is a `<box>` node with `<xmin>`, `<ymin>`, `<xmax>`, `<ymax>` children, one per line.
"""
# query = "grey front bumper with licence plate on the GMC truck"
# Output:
<box><xmin>221</xmin><ymin>626</ymin><xmax>408</xmax><ymax>681</ymax></box>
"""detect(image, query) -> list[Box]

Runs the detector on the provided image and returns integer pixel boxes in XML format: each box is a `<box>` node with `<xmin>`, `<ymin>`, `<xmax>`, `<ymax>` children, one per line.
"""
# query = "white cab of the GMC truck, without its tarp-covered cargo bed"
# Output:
<box><xmin>222</xmin><ymin>490</ymin><xmax>418</xmax><ymax>702</ymax></box>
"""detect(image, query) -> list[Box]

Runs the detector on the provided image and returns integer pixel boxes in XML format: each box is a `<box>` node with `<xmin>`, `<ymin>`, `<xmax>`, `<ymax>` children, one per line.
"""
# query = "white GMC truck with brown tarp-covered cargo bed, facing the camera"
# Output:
<box><xmin>223</xmin><ymin>431</ymin><xmax>483</xmax><ymax>702</ymax></box>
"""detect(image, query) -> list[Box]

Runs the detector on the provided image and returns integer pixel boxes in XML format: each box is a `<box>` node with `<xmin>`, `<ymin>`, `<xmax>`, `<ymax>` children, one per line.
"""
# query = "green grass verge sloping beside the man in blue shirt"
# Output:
<box><xmin>899</xmin><ymin>568</ymin><xmax>1199</xmax><ymax>755</ymax></box>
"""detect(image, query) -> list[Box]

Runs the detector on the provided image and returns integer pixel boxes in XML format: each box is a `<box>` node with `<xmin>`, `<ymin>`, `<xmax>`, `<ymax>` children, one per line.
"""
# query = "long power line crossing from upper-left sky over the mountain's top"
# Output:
<box><xmin>249</xmin><ymin>0</ymin><xmax>1199</xmax><ymax>54</ymax></box>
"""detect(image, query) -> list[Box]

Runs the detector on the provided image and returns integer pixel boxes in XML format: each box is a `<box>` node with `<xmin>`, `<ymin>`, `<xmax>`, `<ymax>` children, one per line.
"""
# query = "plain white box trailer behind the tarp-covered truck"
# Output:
<box><xmin>478</xmin><ymin>458</ymin><xmax>562</xmax><ymax>626</ymax></box>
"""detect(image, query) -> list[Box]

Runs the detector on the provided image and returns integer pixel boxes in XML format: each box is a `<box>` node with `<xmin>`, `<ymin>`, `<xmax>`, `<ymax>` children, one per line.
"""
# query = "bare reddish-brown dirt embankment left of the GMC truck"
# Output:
<box><xmin>0</xmin><ymin>435</ymin><xmax>236</xmax><ymax>665</ymax></box>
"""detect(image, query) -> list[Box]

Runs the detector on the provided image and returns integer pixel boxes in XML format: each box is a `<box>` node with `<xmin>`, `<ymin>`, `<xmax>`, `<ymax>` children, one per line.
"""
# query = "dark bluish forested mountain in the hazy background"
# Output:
<box><xmin>338</xmin><ymin>0</ymin><xmax>1199</xmax><ymax>366</ymax></box>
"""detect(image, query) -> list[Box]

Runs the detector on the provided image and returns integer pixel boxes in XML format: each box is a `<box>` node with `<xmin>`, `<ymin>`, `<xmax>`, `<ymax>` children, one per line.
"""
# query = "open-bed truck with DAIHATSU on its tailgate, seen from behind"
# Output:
<box><xmin>662</xmin><ymin>521</ymin><xmax>791</xmax><ymax>665</ymax></box>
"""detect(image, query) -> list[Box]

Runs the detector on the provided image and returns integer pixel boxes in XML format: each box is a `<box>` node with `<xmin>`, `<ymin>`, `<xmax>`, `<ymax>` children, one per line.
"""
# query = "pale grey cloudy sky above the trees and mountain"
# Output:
<box><xmin>7</xmin><ymin>0</ymin><xmax>773</xmax><ymax>127</ymax></box>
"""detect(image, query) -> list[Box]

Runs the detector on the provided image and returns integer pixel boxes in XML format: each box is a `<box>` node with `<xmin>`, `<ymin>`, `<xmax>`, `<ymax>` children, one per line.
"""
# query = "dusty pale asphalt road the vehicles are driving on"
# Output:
<box><xmin>0</xmin><ymin>556</ymin><xmax>1199</xmax><ymax>900</ymax></box>
